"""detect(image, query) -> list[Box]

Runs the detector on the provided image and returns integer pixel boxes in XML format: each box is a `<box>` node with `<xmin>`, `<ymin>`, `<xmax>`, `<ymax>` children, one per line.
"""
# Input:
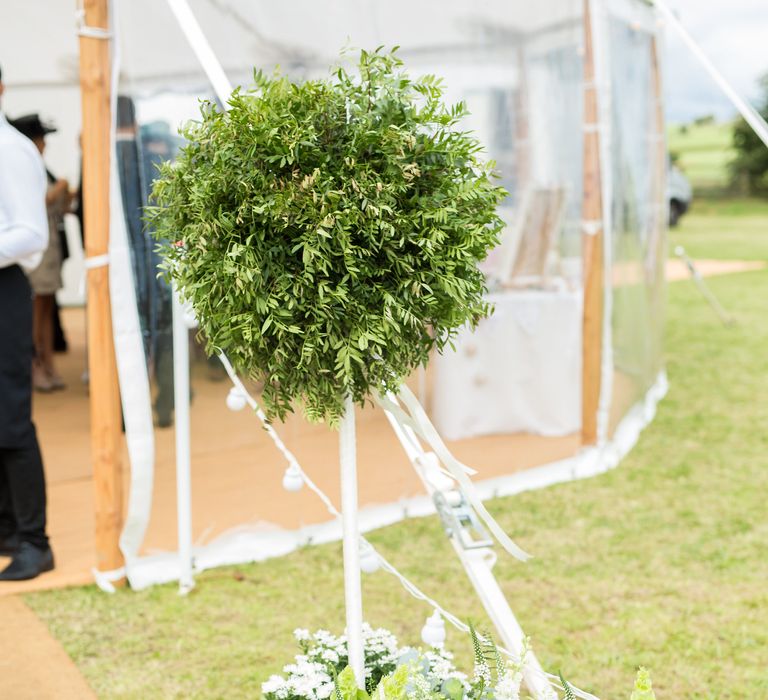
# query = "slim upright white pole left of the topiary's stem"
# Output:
<box><xmin>173</xmin><ymin>290</ymin><xmax>195</xmax><ymax>595</ymax></box>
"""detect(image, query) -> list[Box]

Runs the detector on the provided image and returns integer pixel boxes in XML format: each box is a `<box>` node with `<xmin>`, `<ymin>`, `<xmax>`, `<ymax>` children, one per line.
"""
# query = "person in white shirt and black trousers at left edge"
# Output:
<box><xmin>0</xmin><ymin>64</ymin><xmax>53</xmax><ymax>581</ymax></box>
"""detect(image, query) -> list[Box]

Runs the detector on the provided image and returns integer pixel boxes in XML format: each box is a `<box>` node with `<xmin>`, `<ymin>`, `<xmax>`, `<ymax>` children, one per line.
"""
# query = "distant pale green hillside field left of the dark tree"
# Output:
<box><xmin>667</xmin><ymin>123</ymin><xmax>734</xmax><ymax>193</ymax></box>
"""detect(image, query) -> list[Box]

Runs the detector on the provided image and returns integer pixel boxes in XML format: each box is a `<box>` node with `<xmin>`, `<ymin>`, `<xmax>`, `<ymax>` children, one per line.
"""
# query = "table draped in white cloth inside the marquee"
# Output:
<box><xmin>432</xmin><ymin>290</ymin><xmax>582</xmax><ymax>440</ymax></box>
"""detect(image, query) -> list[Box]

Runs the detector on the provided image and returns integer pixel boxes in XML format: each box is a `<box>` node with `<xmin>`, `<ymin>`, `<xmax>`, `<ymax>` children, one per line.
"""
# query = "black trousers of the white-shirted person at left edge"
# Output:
<box><xmin>0</xmin><ymin>265</ymin><xmax>48</xmax><ymax>547</ymax></box>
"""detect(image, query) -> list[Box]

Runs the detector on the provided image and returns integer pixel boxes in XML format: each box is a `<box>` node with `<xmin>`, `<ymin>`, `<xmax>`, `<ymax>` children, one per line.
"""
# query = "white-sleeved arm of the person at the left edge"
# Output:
<box><xmin>0</xmin><ymin>143</ymin><xmax>48</xmax><ymax>267</ymax></box>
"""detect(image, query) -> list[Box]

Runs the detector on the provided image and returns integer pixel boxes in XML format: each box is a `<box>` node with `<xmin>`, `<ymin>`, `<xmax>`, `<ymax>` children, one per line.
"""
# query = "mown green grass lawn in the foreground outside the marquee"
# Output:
<box><xmin>26</xmin><ymin>202</ymin><xmax>768</xmax><ymax>700</ymax></box>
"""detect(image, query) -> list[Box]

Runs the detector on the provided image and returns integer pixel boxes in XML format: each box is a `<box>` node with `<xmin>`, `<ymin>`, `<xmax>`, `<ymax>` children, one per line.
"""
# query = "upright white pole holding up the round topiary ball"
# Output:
<box><xmin>339</xmin><ymin>396</ymin><xmax>365</xmax><ymax>688</ymax></box>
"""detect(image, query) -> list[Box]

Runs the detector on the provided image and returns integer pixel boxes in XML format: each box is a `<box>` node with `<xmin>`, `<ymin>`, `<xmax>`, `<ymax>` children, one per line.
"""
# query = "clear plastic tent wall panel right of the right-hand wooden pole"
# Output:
<box><xmin>600</xmin><ymin>0</ymin><xmax>667</xmax><ymax>435</ymax></box>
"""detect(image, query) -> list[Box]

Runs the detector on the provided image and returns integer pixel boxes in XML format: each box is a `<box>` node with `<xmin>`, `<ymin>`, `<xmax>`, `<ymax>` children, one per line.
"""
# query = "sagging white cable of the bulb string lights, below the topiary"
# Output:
<box><xmin>219</xmin><ymin>353</ymin><xmax>599</xmax><ymax>700</ymax></box>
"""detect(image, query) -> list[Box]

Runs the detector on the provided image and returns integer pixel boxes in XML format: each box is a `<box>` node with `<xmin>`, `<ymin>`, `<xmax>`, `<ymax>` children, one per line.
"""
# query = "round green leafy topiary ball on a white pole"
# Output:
<box><xmin>149</xmin><ymin>50</ymin><xmax>506</xmax><ymax>425</ymax></box>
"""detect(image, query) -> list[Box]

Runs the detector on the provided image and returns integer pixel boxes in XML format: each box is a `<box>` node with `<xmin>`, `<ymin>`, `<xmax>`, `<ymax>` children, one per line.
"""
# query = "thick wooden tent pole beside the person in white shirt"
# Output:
<box><xmin>80</xmin><ymin>0</ymin><xmax>123</xmax><ymax>571</ymax></box>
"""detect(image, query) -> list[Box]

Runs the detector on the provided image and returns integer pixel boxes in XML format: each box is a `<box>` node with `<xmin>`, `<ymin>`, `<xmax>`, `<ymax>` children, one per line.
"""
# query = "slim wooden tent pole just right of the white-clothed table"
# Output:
<box><xmin>581</xmin><ymin>0</ymin><xmax>604</xmax><ymax>445</ymax></box>
